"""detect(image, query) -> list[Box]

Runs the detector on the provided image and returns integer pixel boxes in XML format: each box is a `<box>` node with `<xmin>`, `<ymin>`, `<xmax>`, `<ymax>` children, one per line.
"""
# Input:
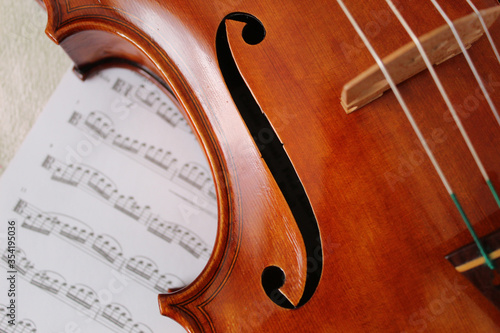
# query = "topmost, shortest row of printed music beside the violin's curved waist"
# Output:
<box><xmin>112</xmin><ymin>78</ymin><xmax>192</xmax><ymax>133</ymax></box>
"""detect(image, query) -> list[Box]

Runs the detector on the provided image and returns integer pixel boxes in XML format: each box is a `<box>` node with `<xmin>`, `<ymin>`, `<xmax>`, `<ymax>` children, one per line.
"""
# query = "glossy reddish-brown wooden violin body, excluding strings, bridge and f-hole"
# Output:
<box><xmin>39</xmin><ymin>0</ymin><xmax>500</xmax><ymax>332</ymax></box>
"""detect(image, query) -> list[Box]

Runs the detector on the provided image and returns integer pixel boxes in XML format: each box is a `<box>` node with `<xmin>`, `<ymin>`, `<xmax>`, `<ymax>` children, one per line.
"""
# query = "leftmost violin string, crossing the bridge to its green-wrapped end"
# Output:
<box><xmin>337</xmin><ymin>0</ymin><xmax>495</xmax><ymax>269</ymax></box>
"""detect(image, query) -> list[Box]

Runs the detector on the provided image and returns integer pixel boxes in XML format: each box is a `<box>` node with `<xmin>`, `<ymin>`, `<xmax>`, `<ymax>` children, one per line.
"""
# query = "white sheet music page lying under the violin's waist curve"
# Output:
<box><xmin>0</xmin><ymin>69</ymin><xmax>217</xmax><ymax>333</ymax></box>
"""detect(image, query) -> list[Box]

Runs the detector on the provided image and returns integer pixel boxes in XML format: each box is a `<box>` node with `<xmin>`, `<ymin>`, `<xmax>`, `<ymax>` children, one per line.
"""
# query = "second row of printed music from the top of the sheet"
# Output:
<box><xmin>68</xmin><ymin>111</ymin><xmax>217</xmax><ymax>205</ymax></box>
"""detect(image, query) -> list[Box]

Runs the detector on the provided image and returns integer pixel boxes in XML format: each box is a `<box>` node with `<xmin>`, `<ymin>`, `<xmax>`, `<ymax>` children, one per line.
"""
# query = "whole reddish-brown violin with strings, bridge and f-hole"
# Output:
<box><xmin>37</xmin><ymin>0</ymin><xmax>500</xmax><ymax>332</ymax></box>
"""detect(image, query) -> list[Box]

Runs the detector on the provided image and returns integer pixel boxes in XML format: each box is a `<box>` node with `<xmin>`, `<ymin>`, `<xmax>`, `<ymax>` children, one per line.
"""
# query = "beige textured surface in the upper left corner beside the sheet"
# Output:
<box><xmin>0</xmin><ymin>0</ymin><xmax>71</xmax><ymax>174</ymax></box>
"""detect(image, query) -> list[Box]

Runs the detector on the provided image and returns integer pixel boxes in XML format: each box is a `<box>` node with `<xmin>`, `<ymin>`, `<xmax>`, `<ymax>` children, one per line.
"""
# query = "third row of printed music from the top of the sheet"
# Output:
<box><xmin>40</xmin><ymin>155</ymin><xmax>210</xmax><ymax>259</ymax></box>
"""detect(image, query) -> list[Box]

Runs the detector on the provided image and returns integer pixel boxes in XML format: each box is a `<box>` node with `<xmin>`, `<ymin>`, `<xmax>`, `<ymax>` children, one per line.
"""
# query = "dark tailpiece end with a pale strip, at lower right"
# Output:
<box><xmin>446</xmin><ymin>230</ymin><xmax>500</xmax><ymax>310</ymax></box>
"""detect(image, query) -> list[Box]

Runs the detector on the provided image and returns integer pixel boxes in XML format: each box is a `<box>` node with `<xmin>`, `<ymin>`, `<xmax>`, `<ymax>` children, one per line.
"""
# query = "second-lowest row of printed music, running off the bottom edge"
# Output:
<box><xmin>0</xmin><ymin>248</ymin><xmax>153</xmax><ymax>333</ymax></box>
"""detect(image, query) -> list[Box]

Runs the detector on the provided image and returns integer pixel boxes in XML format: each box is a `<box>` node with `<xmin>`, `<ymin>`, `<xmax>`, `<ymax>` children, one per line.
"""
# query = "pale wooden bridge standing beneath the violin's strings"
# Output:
<box><xmin>340</xmin><ymin>6</ymin><xmax>500</xmax><ymax>113</ymax></box>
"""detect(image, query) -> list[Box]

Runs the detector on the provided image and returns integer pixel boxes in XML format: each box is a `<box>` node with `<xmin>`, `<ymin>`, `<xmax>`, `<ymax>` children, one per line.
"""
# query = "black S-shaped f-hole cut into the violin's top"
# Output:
<box><xmin>216</xmin><ymin>13</ymin><xmax>323</xmax><ymax>308</ymax></box>
